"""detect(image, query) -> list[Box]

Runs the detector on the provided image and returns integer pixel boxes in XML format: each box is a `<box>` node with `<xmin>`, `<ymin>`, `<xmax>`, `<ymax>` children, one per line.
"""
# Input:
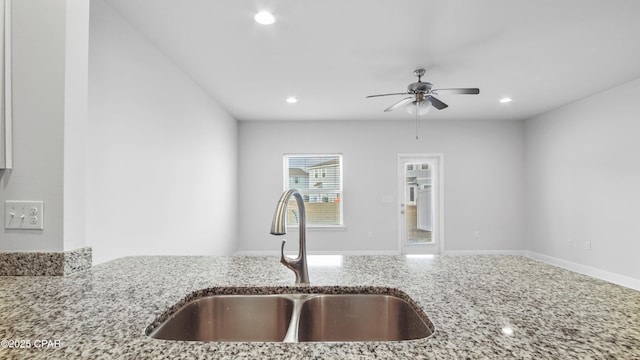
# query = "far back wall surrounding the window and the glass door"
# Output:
<box><xmin>238</xmin><ymin>120</ymin><xmax>525</xmax><ymax>253</ymax></box>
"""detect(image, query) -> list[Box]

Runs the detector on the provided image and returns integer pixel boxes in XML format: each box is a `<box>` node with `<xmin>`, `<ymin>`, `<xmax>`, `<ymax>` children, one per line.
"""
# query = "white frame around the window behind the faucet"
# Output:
<box><xmin>282</xmin><ymin>153</ymin><xmax>345</xmax><ymax>230</ymax></box>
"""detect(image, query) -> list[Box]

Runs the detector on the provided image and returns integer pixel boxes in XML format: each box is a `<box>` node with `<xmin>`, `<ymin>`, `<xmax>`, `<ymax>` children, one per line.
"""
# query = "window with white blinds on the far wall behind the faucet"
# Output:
<box><xmin>284</xmin><ymin>154</ymin><xmax>343</xmax><ymax>227</ymax></box>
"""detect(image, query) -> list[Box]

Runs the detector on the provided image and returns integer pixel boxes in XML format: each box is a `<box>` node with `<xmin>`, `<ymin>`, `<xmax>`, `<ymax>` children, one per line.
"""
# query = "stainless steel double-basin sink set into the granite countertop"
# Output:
<box><xmin>145</xmin><ymin>288</ymin><xmax>434</xmax><ymax>342</ymax></box>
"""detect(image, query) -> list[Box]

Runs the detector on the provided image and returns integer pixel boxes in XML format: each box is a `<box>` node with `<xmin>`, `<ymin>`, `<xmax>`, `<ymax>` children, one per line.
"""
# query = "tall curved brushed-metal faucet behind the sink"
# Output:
<box><xmin>271</xmin><ymin>189</ymin><xmax>309</xmax><ymax>284</ymax></box>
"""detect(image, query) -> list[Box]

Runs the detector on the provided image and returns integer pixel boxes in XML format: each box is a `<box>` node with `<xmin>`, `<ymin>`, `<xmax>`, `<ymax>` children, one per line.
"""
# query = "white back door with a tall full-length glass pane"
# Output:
<box><xmin>398</xmin><ymin>154</ymin><xmax>444</xmax><ymax>254</ymax></box>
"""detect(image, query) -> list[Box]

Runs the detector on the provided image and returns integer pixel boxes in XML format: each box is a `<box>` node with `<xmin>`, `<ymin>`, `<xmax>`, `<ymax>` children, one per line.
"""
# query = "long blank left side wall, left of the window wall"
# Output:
<box><xmin>87</xmin><ymin>1</ymin><xmax>237</xmax><ymax>263</ymax></box>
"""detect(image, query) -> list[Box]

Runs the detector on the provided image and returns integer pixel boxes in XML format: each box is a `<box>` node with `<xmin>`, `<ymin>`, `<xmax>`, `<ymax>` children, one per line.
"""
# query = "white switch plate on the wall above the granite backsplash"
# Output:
<box><xmin>4</xmin><ymin>200</ymin><xmax>44</xmax><ymax>230</ymax></box>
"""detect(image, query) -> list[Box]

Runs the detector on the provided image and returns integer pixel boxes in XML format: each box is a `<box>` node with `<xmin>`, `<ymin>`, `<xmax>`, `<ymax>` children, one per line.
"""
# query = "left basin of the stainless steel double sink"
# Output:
<box><xmin>149</xmin><ymin>295</ymin><xmax>293</xmax><ymax>341</ymax></box>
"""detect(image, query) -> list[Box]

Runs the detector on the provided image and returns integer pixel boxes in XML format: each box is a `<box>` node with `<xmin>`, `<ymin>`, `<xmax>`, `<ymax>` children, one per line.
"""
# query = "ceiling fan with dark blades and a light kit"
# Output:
<box><xmin>367</xmin><ymin>69</ymin><xmax>480</xmax><ymax>115</ymax></box>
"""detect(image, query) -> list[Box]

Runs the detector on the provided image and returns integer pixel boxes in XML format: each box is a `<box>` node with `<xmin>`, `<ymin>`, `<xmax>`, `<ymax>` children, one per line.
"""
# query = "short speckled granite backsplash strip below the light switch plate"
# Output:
<box><xmin>0</xmin><ymin>247</ymin><xmax>91</xmax><ymax>276</ymax></box>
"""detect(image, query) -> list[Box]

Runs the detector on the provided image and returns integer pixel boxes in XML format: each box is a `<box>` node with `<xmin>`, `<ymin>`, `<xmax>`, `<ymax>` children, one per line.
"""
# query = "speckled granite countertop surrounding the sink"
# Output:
<box><xmin>0</xmin><ymin>256</ymin><xmax>640</xmax><ymax>359</ymax></box>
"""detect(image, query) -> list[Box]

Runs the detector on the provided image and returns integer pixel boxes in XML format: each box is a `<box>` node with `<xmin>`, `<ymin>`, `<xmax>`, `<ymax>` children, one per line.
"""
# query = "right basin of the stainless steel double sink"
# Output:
<box><xmin>298</xmin><ymin>295</ymin><xmax>431</xmax><ymax>342</ymax></box>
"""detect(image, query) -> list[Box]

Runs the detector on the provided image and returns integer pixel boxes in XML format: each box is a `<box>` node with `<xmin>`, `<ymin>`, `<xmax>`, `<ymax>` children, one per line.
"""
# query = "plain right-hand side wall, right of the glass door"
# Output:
<box><xmin>525</xmin><ymin>80</ymin><xmax>640</xmax><ymax>279</ymax></box>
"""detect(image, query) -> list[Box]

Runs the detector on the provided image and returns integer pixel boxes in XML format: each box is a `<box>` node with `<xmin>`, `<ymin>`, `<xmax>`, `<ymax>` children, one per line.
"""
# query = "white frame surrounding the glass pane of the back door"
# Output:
<box><xmin>396</xmin><ymin>153</ymin><xmax>445</xmax><ymax>255</ymax></box>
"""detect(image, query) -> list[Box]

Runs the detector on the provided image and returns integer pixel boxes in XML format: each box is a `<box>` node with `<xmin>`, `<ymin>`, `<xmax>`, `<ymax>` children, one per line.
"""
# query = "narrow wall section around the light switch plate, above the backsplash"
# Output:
<box><xmin>0</xmin><ymin>0</ymin><xmax>66</xmax><ymax>251</ymax></box>
